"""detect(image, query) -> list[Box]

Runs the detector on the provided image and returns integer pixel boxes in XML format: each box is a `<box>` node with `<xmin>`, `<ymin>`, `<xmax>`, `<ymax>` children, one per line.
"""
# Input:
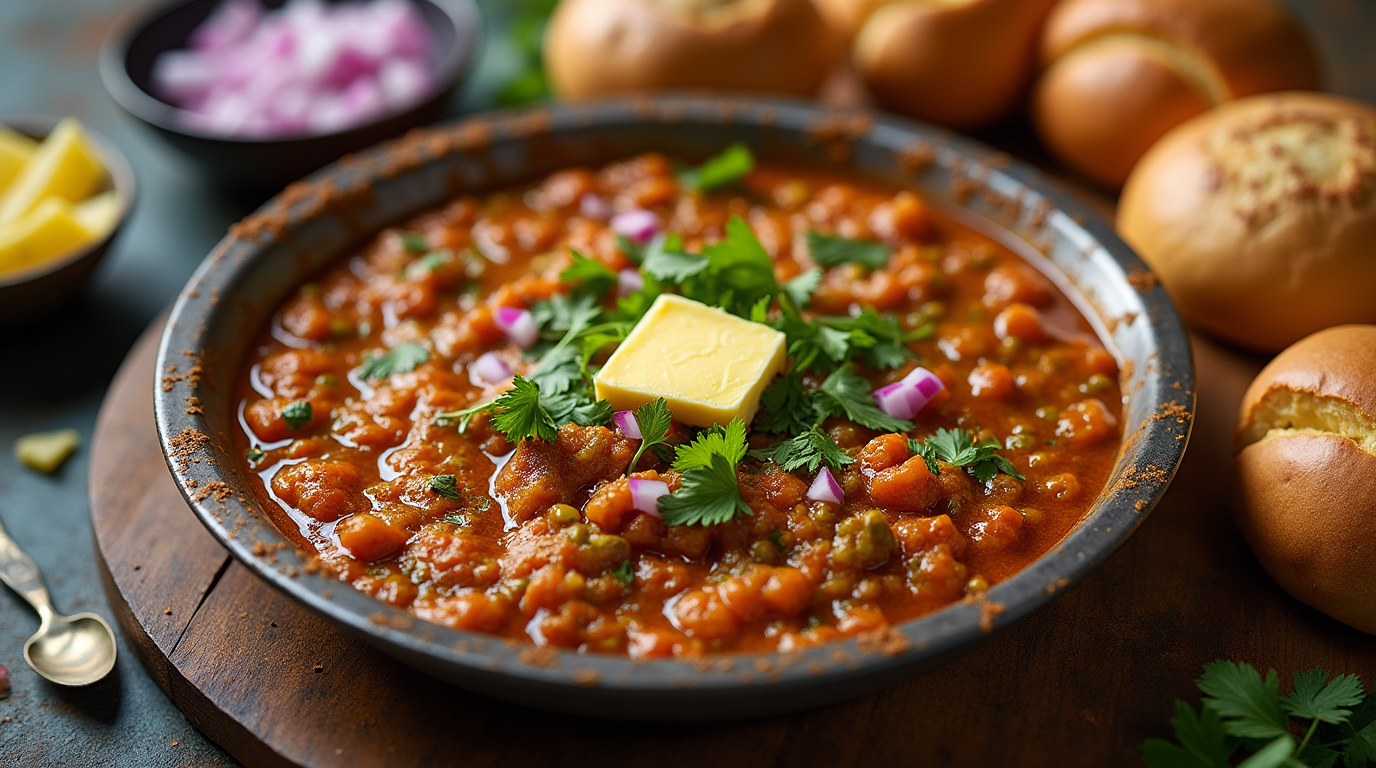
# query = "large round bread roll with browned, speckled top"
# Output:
<box><xmin>1117</xmin><ymin>92</ymin><xmax>1376</xmax><ymax>351</ymax></box>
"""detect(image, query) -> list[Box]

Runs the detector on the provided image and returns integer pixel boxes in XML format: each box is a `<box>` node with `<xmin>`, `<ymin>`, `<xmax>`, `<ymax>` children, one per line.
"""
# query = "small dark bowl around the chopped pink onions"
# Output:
<box><xmin>100</xmin><ymin>0</ymin><xmax>483</xmax><ymax>194</ymax></box>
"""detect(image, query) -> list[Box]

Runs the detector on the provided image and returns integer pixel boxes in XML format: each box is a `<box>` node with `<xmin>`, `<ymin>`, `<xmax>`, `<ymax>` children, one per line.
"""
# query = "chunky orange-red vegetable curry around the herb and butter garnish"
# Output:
<box><xmin>237</xmin><ymin>154</ymin><xmax>1123</xmax><ymax>658</ymax></box>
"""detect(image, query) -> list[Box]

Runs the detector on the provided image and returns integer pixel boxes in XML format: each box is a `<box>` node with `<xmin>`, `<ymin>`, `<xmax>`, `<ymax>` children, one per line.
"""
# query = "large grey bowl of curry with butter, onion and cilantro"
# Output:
<box><xmin>155</xmin><ymin>95</ymin><xmax>1194</xmax><ymax>720</ymax></box>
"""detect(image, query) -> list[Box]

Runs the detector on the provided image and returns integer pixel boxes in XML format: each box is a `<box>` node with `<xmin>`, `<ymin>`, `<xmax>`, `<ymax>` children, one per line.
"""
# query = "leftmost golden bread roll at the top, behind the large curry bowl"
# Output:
<box><xmin>544</xmin><ymin>0</ymin><xmax>837</xmax><ymax>100</ymax></box>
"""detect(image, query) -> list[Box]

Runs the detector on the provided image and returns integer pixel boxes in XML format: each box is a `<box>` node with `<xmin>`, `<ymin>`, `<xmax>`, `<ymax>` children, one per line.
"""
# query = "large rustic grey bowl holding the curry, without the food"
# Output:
<box><xmin>154</xmin><ymin>96</ymin><xmax>1194</xmax><ymax>720</ymax></box>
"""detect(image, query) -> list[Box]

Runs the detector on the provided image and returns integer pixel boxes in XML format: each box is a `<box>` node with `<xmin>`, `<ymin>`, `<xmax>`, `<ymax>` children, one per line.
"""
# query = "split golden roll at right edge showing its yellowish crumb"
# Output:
<box><xmin>1234</xmin><ymin>325</ymin><xmax>1376</xmax><ymax>633</ymax></box>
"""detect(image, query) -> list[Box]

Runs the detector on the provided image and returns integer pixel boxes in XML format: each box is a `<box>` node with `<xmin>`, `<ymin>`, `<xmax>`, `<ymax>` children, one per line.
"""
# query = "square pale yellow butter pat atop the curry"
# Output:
<box><xmin>593</xmin><ymin>293</ymin><xmax>786</xmax><ymax>427</ymax></box>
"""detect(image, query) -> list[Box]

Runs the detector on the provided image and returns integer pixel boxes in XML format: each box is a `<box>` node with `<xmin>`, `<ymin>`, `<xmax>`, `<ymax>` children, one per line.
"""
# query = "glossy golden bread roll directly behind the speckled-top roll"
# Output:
<box><xmin>1032</xmin><ymin>0</ymin><xmax>1318</xmax><ymax>189</ymax></box>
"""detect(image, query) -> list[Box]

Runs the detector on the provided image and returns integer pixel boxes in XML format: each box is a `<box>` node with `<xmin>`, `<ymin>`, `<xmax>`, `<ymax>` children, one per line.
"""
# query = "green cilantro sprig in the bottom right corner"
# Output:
<box><xmin>1138</xmin><ymin>661</ymin><xmax>1376</xmax><ymax>768</ymax></box>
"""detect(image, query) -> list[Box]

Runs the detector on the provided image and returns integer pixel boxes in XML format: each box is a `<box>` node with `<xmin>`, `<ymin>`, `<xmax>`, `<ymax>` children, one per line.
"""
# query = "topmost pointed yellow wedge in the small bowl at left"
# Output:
<box><xmin>0</xmin><ymin>118</ymin><xmax>105</xmax><ymax>224</ymax></box>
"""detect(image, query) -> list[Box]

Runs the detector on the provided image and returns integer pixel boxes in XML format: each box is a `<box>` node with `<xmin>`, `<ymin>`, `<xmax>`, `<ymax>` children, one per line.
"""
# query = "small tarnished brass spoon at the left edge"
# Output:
<box><xmin>0</xmin><ymin>524</ymin><xmax>116</xmax><ymax>685</ymax></box>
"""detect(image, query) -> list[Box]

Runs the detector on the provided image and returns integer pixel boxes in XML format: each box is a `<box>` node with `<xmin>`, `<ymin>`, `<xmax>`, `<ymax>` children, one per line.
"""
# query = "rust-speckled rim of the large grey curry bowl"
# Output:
<box><xmin>154</xmin><ymin>94</ymin><xmax>1194</xmax><ymax>718</ymax></box>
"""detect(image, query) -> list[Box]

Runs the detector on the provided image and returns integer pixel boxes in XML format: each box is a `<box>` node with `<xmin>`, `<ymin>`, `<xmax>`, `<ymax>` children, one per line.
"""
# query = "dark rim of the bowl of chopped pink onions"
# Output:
<box><xmin>98</xmin><ymin>0</ymin><xmax>486</xmax><ymax>147</ymax></box>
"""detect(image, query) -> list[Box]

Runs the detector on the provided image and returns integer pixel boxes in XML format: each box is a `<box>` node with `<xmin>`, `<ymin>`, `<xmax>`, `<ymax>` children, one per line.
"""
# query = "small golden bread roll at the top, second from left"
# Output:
<box><xmin>852</xmin><ymin>0</ymin><xmax>1054</xmax><ymax>128</ymax></box>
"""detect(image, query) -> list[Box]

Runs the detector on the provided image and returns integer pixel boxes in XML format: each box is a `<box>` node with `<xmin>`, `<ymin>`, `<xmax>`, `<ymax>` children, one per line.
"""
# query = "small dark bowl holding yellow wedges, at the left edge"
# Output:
<box><xmin>0</xmin><ymin>117</ymin><xmax>136</xmax><ymax>328</ymax></box>
